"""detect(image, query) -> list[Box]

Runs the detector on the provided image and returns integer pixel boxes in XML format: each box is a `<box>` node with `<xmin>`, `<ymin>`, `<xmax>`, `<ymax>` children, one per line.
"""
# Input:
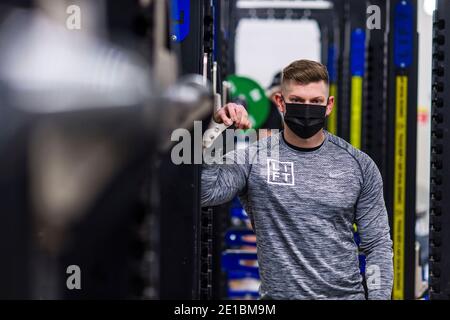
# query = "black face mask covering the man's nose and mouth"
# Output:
<box><xmin>284</xmin><ymin>97</ymin><xmax>327</xmax><ymax>139</ymax></box>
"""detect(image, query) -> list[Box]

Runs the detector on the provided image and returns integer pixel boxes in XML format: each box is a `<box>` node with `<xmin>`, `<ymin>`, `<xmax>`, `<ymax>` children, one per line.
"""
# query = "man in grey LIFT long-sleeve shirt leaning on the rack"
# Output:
<box><xmin>201</xmin><ymin>60</ymin><xmax>393</xmax><ymax>299</ymax></box>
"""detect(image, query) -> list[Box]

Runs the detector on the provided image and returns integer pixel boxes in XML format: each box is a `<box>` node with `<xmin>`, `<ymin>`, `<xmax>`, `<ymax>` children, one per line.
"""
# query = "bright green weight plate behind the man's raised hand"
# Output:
<box><xmin>226</xmin><ymin>75</ymin><xmax>270</xmax><ymax>129</ymax></box>
